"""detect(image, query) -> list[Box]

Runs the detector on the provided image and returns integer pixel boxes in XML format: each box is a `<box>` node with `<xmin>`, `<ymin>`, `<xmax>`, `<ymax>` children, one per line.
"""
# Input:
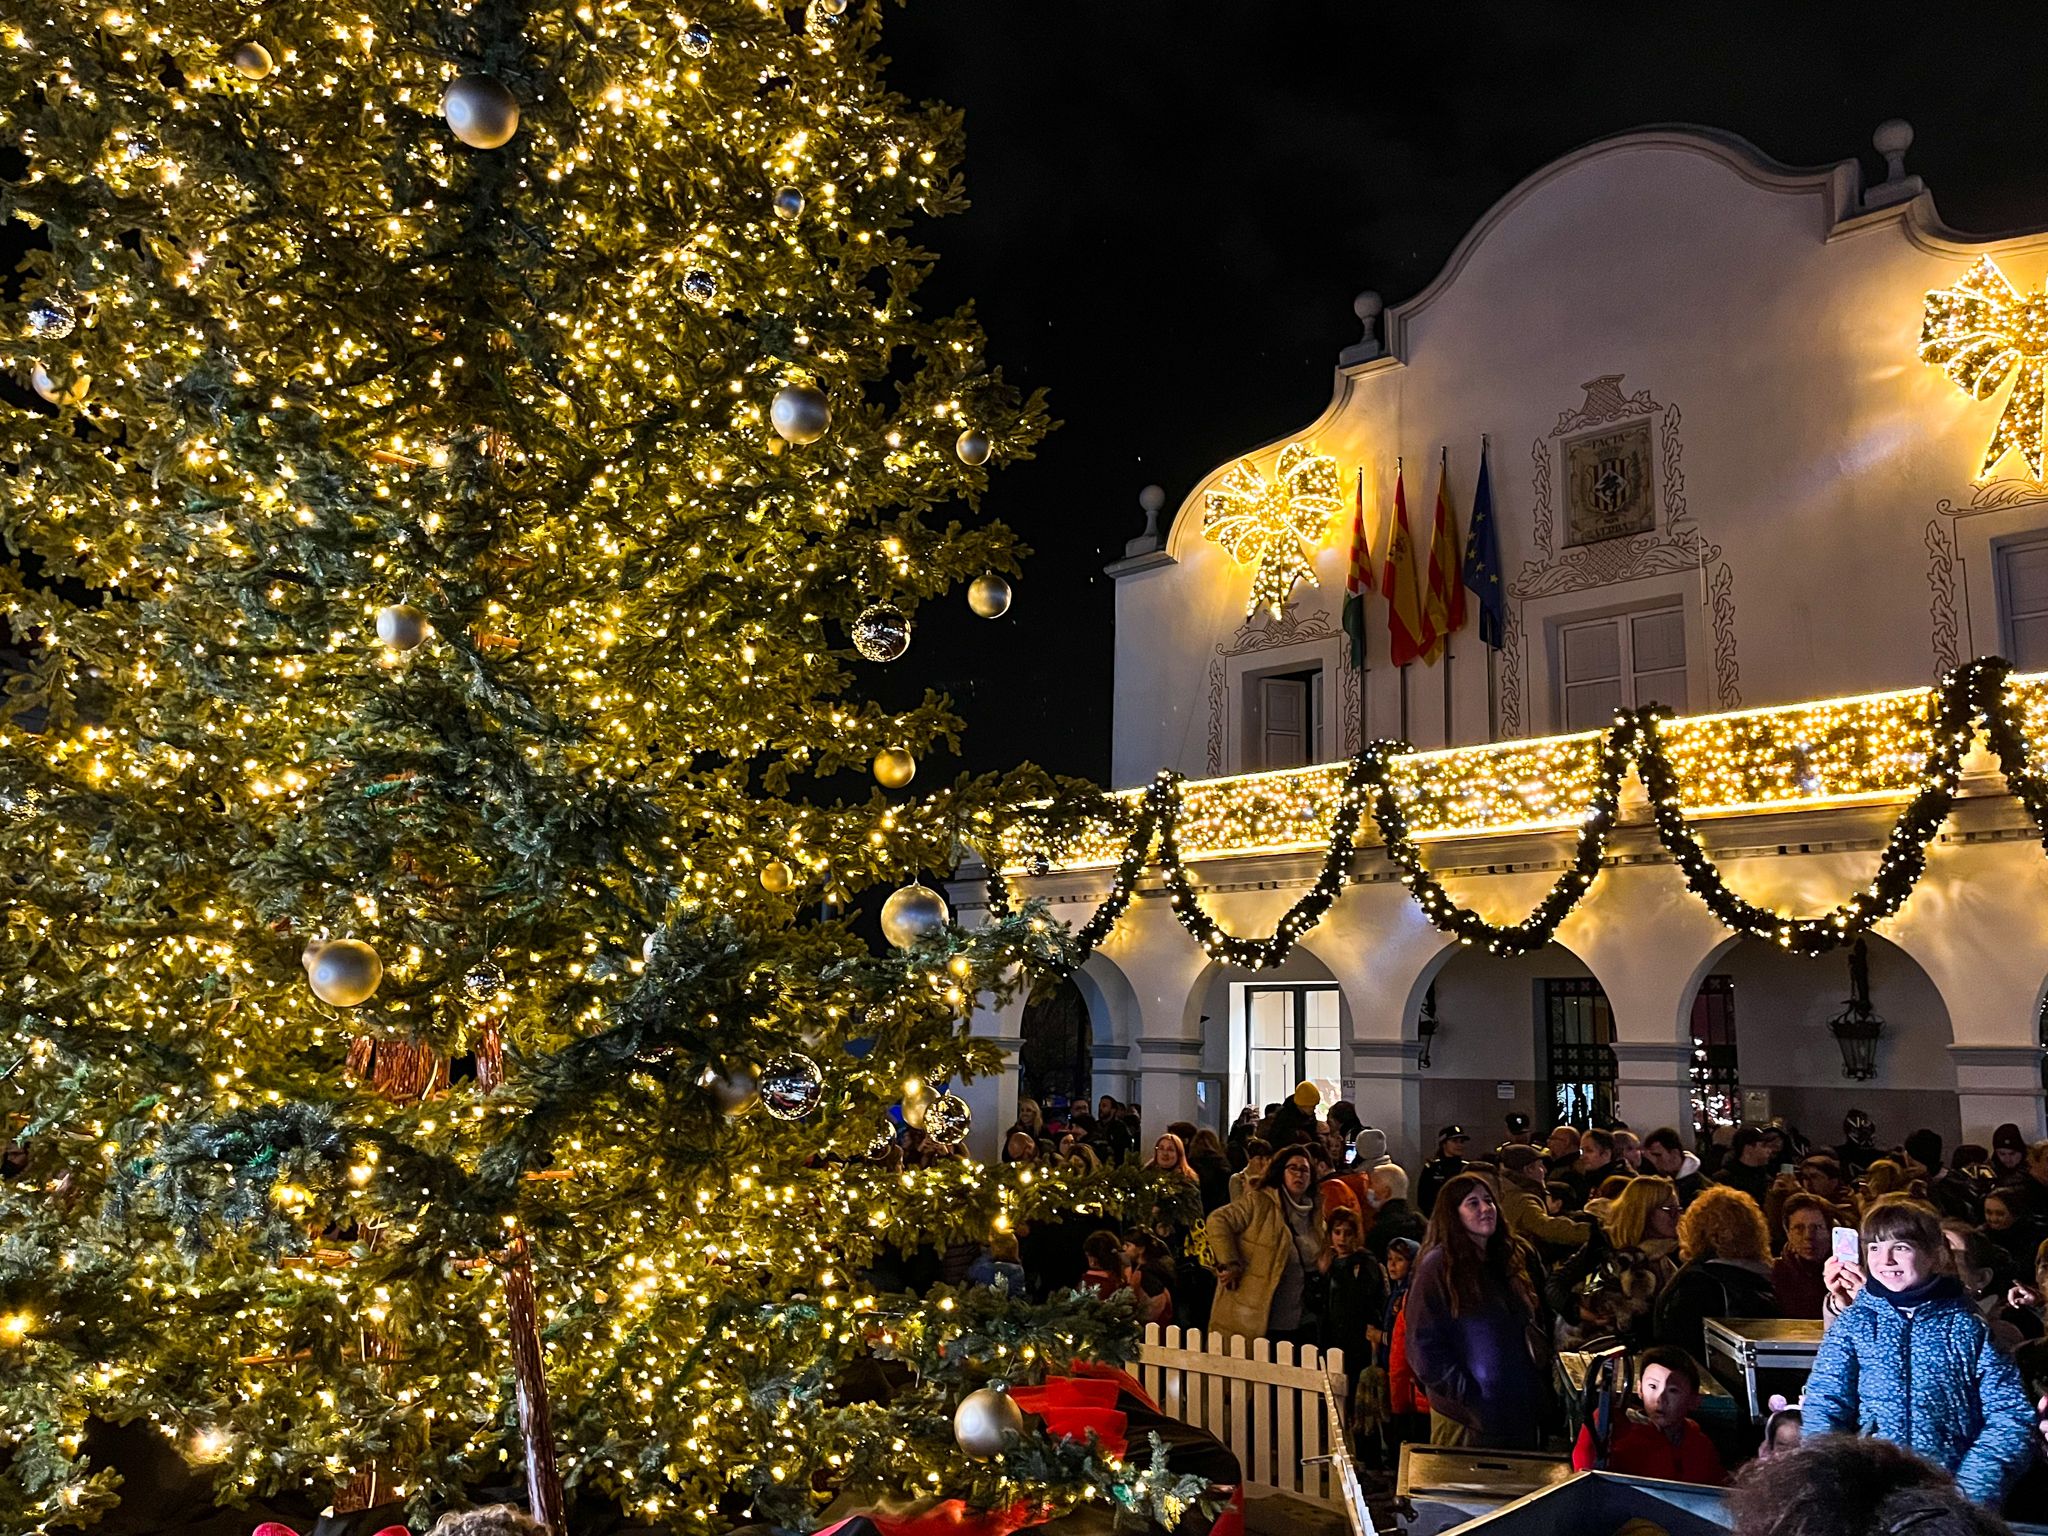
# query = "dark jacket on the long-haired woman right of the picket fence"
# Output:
<box><xmin>1405</xmin><ymin>1247</ymin><xmax>1548</xmax><ymax>1450</ymax></box>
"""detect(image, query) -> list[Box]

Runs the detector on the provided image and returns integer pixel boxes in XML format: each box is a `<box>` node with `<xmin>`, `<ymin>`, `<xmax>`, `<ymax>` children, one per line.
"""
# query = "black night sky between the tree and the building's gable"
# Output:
<box><xmin>883</xmin><ymin>0</ymin><xmax>2048</xmax><ymax>782</ymax></box>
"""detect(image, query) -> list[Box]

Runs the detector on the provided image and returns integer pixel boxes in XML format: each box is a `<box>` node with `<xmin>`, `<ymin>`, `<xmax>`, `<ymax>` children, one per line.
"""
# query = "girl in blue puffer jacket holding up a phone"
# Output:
<box><xmin>1804</xmin><ymin>1194</ymin><xmax>2034</xmax><ymax>1509</ymax></box>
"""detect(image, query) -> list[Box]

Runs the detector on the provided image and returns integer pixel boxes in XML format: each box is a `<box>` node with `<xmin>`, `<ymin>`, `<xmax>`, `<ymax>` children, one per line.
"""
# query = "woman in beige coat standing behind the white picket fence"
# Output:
<box><xmin>1206</xmin><ymin>1145</ymin><xmax>1331</xmax><ymax>1343</ymax></box>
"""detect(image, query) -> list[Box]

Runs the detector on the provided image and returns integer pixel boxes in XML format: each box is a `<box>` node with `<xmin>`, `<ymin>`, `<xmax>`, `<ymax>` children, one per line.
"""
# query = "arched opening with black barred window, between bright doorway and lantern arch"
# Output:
<box><xmin>1407</xmin><ymin>942</ymin><xmax>1628</xmax><ymax>1149</ymax></box>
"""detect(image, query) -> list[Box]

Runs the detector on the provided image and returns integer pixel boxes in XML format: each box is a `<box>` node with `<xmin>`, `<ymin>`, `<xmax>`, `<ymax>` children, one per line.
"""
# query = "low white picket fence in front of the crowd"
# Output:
<box><xmin>1137</xmin><ymin>1323</ymin><xmax>1374</xmax><ymax>1536</ymax></box>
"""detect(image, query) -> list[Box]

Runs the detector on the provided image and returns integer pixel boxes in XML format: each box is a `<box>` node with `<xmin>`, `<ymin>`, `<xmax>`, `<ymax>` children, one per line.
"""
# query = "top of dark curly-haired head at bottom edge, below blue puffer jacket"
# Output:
<box><xmin>1729</xmin><ymin>1436</ymin><xmax>2011</xmax><ymax>1536</ymax></box>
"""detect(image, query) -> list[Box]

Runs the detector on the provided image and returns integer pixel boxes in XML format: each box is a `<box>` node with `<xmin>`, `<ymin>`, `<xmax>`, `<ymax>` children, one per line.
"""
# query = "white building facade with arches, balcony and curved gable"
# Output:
<box><xmin>954</xmin><ymin>125</ymin><xmax>2048</xmax><ymax>1161</ymax></box>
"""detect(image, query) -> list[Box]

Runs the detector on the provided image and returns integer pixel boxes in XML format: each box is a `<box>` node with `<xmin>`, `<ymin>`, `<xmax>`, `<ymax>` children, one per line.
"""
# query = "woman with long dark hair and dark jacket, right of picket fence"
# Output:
<box><xmin>1403</xmin><ymin>1174</ymin><xmax>1550</xmax><ymax>1450</ymax></box>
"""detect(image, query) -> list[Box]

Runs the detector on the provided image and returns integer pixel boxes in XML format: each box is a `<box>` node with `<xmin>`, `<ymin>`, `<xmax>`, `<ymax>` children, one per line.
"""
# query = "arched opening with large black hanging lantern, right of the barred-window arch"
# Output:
<box><xmin>1690</xmin><ymin>934</ymin><xmax>1962</xmax><ymax>1147</ymax></box>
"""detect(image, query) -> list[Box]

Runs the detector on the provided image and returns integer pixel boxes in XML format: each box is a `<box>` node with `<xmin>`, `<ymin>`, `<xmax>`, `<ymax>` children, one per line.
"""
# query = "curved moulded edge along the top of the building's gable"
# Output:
<box><xmin>1165</xmin><ymin>123</ymin><xmax>2048</xmax><ymax>559</ymax></box>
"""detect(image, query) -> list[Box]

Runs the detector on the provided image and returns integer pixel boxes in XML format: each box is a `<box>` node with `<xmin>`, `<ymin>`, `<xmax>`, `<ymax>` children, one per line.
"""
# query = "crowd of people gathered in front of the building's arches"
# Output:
<box><xmin>981</xmin><ymin>1083</ymin><xmax>2048</xmax><ymax>1513</ymax></box>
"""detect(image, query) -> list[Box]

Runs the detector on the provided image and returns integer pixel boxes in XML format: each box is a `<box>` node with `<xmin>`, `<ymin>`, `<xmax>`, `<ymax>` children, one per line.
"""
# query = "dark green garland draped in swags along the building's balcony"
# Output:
<box><xmin>987</xmin><ymin>655</ymin><xmax>2048</xmax><ymax>971</ymax></box>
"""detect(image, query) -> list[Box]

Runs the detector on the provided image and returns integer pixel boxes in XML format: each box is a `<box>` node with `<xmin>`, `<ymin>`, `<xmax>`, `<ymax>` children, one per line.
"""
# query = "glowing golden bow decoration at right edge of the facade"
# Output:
<box><xmin>1921</xmin><ymin>256</ymin><xmax>2048</xmax><ymax>479</ymax></box>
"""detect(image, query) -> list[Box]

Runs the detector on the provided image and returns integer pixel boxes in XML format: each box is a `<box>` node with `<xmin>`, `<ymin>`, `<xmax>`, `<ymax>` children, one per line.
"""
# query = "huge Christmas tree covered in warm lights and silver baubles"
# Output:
<box><xmin>0</xmin><ymin>0</ymin><xmax>1187</xmax><ymax>1532</ymax></box>
